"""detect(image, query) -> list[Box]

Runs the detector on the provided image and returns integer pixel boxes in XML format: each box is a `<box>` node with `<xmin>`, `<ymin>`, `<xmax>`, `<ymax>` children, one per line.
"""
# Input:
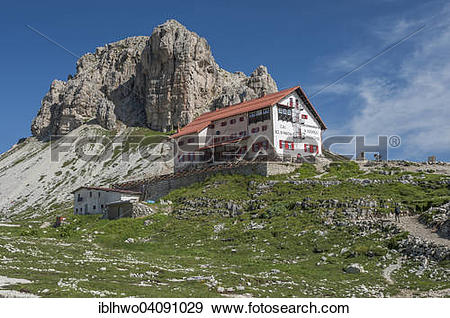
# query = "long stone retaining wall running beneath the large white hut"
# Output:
<box><xmin>112</xmin><ymin>162</ymin><xmax>299</xmax><ymax>201</ymax></box>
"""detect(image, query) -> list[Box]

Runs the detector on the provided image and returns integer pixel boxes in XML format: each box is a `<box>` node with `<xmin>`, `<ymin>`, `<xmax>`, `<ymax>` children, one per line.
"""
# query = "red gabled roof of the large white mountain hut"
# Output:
<box><xmin>171</xmin><ymin>86</ymin><xmax>326</xmax><ymax>138</ymax></box>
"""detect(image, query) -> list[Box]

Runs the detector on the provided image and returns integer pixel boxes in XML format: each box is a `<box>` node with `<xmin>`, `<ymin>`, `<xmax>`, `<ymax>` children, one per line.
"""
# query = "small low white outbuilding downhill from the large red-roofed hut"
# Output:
<box><xmin>73</xmin><ymin>187</ymin><xmax>140</xmax><ymax>214</ymax></box>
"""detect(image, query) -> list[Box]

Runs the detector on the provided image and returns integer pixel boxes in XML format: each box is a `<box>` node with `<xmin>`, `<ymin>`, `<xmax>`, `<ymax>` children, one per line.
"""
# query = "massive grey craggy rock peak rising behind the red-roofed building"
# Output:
<box><xmin>31</xmin><ymin>20</ymin><xmax>277</xmax><ymax>138</ymax></box>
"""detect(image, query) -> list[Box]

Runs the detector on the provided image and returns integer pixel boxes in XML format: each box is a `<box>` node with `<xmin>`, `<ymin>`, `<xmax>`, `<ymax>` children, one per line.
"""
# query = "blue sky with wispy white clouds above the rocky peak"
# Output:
<box><xmin>0</xmin><ymin>0</ymin><xmax>450</xmax><ymax>161</ymax></box>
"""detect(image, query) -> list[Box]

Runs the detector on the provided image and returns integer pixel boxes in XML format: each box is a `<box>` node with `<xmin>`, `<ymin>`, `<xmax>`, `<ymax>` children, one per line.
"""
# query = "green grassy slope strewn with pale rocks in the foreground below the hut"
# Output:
<box><xmin>0</xmin><ymin>163</ymin><xmax>450</xmax><ymax>297</ymax></box>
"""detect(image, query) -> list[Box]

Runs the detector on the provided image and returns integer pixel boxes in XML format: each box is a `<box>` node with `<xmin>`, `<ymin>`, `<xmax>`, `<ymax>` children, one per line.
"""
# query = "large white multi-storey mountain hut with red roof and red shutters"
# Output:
<box><xmin>171</xmin><ymin>86</ymin><xmax>326</xmax><ymax>170</ymax></box>
